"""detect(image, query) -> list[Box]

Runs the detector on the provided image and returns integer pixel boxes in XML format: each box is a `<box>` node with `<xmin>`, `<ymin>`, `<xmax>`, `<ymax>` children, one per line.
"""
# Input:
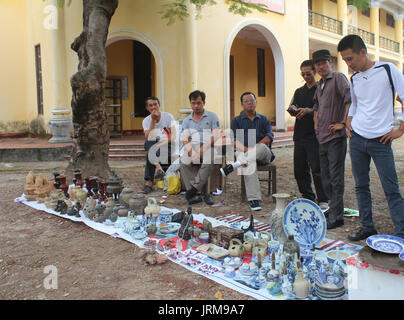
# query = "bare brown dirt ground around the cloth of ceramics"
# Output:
<box><xmin>0</xmin><ymin>139</ymin><xmax>404</xmax><ymax>300</ymax></box>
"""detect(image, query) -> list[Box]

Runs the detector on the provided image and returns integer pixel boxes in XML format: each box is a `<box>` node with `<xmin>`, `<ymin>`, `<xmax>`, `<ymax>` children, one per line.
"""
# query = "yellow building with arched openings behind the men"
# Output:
<box><xmin>0</xmin><ymin>0</ymin><xmax>404</xmax><ymax>140</ymax></box>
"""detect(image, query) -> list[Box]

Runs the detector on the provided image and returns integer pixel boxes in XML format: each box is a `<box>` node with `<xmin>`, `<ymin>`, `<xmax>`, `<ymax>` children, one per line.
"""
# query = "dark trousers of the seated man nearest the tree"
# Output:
<box><xmin>144</xmin><ymin>141</ymin><xmax>171</xmax><ymax>181</ymax></box>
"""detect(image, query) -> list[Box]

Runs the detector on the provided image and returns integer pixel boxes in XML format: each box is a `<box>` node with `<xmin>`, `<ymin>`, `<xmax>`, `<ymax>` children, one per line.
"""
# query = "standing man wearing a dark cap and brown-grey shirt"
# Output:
<box><xmin>312</xmin><ymin>50</ymin><xmax>351</xmax><ymax>229</ymax></box>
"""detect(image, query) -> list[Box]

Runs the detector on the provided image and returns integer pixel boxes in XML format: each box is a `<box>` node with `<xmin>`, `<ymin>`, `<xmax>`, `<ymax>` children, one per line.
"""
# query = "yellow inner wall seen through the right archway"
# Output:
<box><xmin>231</xmin><ymin>38</ymin><xmax>275</xmax><ymax>120</ymax></box>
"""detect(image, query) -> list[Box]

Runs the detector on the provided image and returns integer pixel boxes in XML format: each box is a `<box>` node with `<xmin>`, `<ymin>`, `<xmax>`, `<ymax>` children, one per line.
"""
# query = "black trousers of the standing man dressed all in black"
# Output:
<box><xmin>293</xmin><ymin>136</ymin><xmax>328</xmax><ymax>202</ymax></box>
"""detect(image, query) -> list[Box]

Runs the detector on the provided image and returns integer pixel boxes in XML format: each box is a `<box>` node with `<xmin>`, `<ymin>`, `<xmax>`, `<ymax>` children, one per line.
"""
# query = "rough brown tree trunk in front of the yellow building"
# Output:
<box><xmin>67</xmin><ymin>0</ymin><xmax>118</xmax><ymax>179</ymax></box>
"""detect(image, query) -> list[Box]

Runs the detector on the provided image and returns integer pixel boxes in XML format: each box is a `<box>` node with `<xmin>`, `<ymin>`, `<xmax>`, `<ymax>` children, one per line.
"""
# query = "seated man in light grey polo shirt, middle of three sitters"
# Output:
<box><xmin>180</xmin><ymin>90</ymin><xmax>220</xmax><ymax>205</ymax></box>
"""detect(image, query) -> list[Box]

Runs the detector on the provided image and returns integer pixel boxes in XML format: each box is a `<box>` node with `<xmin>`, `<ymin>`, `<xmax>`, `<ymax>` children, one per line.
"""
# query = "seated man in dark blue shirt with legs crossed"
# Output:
<box><xmin>220</xmin><ymin>92</ymin><xmax>275</xmax><ymax>211</ymax></box>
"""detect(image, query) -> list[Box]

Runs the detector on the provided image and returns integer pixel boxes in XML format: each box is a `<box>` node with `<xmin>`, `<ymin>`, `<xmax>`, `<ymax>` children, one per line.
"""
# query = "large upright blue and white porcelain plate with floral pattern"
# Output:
<box><xmin>283</xmin><ymin>198</ymin><xmax>327</xmax><ymax>249</ymax></box>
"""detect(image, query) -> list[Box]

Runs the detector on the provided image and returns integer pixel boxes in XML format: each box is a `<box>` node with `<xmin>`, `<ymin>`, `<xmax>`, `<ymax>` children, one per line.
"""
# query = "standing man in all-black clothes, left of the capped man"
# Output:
<box><xmin>287</xmin><ymin>60</ymin><xmax>328</xmax><ymax>210</ymax></box>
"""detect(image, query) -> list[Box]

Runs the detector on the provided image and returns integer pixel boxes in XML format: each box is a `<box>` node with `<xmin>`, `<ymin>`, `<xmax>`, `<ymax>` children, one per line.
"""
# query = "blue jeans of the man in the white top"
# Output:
<box><xmin>349</xmin><ymin>132</ymin><xmax>404</xmax><ymax>238</ymax></box>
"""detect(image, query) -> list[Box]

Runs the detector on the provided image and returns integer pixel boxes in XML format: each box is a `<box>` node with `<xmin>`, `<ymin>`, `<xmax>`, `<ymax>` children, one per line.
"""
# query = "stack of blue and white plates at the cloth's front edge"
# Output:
<box><xmin>315</xmin><ymin>274</ymin><xmax>346</xmax><ymax>300</ymax></box>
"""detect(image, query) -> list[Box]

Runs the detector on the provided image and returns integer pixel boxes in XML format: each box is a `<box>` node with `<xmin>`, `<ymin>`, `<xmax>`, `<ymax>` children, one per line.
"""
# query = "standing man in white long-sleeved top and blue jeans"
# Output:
<box><xmin>338</xmin><ymin>35</ymin><xmax>404</xmax><ymax>241</ymax></box>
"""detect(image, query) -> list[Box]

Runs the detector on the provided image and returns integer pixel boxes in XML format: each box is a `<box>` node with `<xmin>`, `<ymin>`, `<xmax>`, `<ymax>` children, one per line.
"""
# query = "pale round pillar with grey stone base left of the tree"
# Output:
<box><xmin>49</xmin><ymin>0</ymin><xmax>73</xmax><ymax>143</ymax></box>
